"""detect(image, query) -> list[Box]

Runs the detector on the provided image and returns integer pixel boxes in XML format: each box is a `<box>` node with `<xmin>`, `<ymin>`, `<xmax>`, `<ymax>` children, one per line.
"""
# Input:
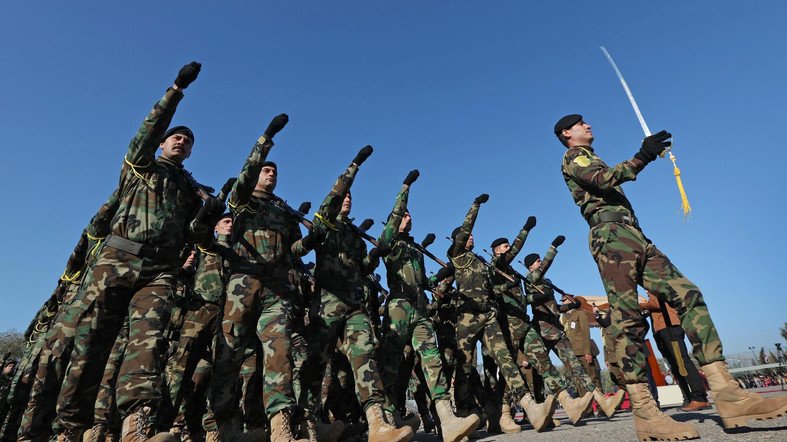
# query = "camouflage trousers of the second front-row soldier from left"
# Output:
<box><xmin>210</xmin><ymin>273</ymin><xmax>295</xmax><ymax>420</ymax></box>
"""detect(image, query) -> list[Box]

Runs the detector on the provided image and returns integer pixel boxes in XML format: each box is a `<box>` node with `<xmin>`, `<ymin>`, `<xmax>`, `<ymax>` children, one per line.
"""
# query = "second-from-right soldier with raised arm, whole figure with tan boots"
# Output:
<box><xmin>491</xmin><ymin>230</ymin><xmax>591</xmax><ymax>433</ymax></box>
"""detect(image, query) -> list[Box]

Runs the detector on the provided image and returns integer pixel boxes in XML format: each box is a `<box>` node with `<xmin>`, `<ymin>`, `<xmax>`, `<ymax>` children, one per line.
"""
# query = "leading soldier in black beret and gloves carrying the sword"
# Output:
<box><xmin>554</xmin><ymin>114</ymin><xmax>787</xmax><ymax>439</ymax></box>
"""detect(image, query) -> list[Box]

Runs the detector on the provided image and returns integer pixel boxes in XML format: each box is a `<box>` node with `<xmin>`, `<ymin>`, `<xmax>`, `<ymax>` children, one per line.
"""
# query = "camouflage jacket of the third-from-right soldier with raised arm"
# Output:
<box><xmin>448</xmin><ymin>203</ymin><xmax>497</xmax><ymax>312</ymax></box>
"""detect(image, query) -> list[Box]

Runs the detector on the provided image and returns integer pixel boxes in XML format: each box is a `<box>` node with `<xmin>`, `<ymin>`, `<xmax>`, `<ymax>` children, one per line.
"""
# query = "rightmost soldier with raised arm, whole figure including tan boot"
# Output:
<box><xmin>524</xmin><ymin>247</ymin><xmax>623</xmax><ymax>417</ymax></box>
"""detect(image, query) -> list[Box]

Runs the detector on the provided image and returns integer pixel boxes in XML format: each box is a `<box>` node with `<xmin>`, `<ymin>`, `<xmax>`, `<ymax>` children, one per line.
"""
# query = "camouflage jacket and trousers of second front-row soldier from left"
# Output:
<box><xmin>209</xmin><ymin>135</ymin><xmax>307</xmax><ymax>421</ymax></box>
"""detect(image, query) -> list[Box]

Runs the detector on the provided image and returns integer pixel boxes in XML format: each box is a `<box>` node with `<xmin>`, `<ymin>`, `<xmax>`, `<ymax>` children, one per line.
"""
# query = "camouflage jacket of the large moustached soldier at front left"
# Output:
<box><xmin>111</xmin><ymin>89</ymin><xmax>213</xmax><ymax>273</ymax></box>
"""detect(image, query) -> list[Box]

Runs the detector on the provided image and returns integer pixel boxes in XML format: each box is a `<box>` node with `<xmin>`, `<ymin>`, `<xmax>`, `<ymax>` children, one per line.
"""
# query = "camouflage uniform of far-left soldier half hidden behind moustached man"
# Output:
<box><xmin>18</xmin><ymin>191</ymin><xmax>119</xmax><ymax>440</ymax></box>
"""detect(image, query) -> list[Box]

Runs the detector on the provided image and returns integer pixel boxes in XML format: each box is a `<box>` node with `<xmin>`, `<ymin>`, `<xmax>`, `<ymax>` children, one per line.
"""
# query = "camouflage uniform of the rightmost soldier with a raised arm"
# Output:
<box><xmin>525</xmin><ymin>246</ymin><xmax>595</xmax><ymax>392</ymax></box>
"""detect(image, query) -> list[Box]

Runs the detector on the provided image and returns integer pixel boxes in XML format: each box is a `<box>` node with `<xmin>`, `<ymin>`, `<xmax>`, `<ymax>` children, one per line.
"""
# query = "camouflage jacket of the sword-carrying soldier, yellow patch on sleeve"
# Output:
<box><xmin>562</xmin><ymin>146</ymin><xmax>645</xmax><ymax>221</ymax></box>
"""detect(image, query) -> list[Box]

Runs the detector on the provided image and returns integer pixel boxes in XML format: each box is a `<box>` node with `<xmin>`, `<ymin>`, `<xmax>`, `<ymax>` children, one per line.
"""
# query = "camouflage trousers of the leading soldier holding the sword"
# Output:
<box><xmin>589</xmin><ymin>223</ymin><xmax>724</xmax><ymax>384</ymax></box>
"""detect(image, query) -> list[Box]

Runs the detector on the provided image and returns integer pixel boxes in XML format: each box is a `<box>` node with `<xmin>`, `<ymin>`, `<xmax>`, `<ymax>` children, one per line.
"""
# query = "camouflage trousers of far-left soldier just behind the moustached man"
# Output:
<box><xmin>18</xmin><ymin>286</ymin><xmax>93</xmax><ymax>440</ymax></box>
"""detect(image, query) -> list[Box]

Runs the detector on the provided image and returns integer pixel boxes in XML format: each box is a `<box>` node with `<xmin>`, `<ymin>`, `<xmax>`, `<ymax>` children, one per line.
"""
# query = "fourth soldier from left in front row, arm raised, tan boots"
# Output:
<box><xmin>377</xmin><ymin>170</ymin><xmax>480</xmax><ymax>442</ymax></box>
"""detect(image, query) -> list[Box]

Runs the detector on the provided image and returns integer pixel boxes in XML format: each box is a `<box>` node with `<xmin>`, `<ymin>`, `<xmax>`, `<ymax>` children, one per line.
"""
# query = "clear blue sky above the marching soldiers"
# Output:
<box><xmin>0</xmin><ymin>1</ymin><xmax>787</xmax><ymax>360</ymax></box>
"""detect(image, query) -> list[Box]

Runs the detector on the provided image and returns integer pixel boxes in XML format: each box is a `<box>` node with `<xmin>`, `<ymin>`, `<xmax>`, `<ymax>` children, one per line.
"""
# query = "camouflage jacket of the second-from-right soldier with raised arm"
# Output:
<box><xmin>492</xmin><ymin>229</ymin><xmax>529</xmax><ymax>320</ymax></box>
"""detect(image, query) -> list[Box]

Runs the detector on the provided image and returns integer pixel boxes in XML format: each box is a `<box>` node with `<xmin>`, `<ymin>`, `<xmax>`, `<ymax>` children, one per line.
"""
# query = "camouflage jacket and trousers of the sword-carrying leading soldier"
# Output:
<box><xmin>562</xmin><ymin>146</ymin><xmax>724</xmax><ymax>384</ymax></box>
